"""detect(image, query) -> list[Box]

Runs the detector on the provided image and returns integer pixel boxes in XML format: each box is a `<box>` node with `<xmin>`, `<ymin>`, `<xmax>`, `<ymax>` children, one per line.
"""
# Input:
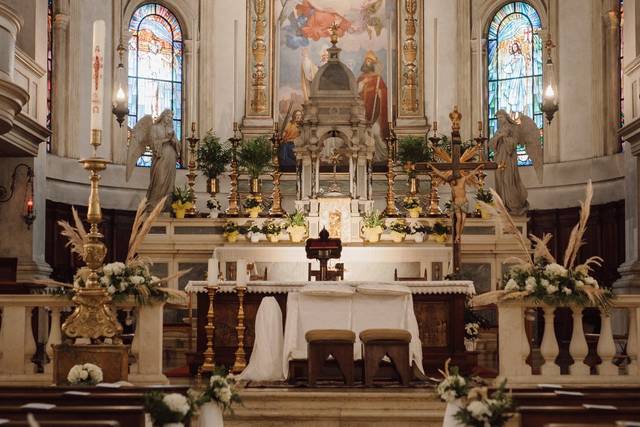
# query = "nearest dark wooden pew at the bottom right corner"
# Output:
<box><xmin>517</xmin><ymin>405</ymin><xmax>640</xmax><ymax>427</ymax></box>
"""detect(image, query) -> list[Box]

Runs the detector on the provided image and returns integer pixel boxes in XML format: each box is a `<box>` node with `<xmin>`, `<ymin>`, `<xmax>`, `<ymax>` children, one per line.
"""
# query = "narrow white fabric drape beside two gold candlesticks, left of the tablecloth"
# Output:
<box><xmin>239</xmin><ymin>297</ymin><xmax>284</xmax><ymax>381</ymax></box>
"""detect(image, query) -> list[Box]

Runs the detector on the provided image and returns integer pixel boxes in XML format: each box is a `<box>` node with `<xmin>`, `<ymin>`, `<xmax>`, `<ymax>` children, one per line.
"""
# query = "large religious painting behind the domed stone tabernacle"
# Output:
<box><xmin>275</xmin><ymin>0</ymin><xmax>396</xmax><ymax>171</ymax></box>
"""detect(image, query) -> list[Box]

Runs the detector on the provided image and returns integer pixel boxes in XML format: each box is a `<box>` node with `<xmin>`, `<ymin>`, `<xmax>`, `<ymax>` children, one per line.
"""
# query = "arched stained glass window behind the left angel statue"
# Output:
<box><xmin>129</xmin><ymin>3</ymin><xmax>183</xmax><ymax>167</ymax></box>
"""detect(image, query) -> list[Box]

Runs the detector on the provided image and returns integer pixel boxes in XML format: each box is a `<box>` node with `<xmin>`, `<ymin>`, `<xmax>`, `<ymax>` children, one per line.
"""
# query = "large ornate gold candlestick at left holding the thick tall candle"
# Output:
<box><xmin>62</xmin><ymin>129</ymin><xmax>122</xmax><ymax>342</ymax></box>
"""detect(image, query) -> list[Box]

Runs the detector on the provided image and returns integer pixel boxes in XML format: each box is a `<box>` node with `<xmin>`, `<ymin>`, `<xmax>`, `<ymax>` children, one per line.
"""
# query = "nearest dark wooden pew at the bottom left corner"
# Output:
<box><xmin>0</xmin><ymin>405</ymin><xmax>145</xmax><ymax>427</ymax></box>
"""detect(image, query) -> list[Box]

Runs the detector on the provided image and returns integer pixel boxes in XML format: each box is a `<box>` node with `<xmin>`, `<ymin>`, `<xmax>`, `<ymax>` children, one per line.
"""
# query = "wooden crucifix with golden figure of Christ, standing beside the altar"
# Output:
<box><xmin>416</xmin><ymin>105</ymin><xmax>497</xmax><ymax>276</ymax></box>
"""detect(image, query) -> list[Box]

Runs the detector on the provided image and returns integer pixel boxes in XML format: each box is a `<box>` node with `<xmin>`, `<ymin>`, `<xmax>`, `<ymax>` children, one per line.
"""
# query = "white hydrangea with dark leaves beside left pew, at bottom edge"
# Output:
<box><xmin>144</xmin><ymin>391</ymin><xmax>195</xmax><ymax>427</ymax></box>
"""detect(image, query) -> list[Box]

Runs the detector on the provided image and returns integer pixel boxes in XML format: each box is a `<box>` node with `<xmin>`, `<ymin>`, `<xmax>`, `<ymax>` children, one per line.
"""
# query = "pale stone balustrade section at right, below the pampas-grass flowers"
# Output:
<box><xmin>498</xmin><ymin>295</ymin><xmax>640</xmax><ymax>385</ymax></box>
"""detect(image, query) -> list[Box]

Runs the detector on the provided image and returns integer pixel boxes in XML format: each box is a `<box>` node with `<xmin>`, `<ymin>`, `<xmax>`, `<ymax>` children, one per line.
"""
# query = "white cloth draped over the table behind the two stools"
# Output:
<box><xmin>282</xmin><ymin>292</ymin><xmax>422</xmax><ymax>378</ymax></box>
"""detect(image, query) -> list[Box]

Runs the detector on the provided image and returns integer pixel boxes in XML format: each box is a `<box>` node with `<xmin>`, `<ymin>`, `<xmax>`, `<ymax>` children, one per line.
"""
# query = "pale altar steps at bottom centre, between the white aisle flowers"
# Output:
<box><xmin>225</xmin><ymin>387</ymin><xmax>445</xmax><ymax>427</ymax></box>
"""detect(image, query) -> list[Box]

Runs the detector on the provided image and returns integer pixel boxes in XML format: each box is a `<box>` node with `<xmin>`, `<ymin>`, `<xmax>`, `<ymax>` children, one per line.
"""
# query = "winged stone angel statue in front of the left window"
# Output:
<box><xmin>127</xmin><ymin>109</ymin><xmax>180</xmax><ymax>211</ymax></box>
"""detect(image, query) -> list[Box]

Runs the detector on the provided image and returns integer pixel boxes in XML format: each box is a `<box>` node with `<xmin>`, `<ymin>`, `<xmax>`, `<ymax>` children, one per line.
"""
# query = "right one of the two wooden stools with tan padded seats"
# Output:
<box><xmin>360</xmin><ymin>329</ymin><xmax>411</xmax><ymax>387</ymax></box>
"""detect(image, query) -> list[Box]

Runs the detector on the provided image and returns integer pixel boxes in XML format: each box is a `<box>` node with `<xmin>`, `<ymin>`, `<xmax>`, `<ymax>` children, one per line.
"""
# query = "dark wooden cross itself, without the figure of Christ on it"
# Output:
<box><xmin>416</xmin><ymin>105</ymin><xmax>497</xmax><ymax>276</ymax></box>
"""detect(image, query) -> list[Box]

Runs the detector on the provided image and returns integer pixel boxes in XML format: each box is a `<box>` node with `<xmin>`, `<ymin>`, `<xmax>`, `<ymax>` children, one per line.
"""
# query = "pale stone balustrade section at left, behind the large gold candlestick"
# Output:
<box><xmin>0</xmin><ymin>295</ymin><xmax>169</xmax><ymax>385</ymax></box>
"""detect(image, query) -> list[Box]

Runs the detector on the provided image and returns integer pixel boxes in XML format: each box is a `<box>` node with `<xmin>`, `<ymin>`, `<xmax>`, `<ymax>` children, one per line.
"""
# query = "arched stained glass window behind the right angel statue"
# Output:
<box><xmin>487</xmin><ymin>1</ymin><xmax>543</xmax><ymax>165</ymax></box>
